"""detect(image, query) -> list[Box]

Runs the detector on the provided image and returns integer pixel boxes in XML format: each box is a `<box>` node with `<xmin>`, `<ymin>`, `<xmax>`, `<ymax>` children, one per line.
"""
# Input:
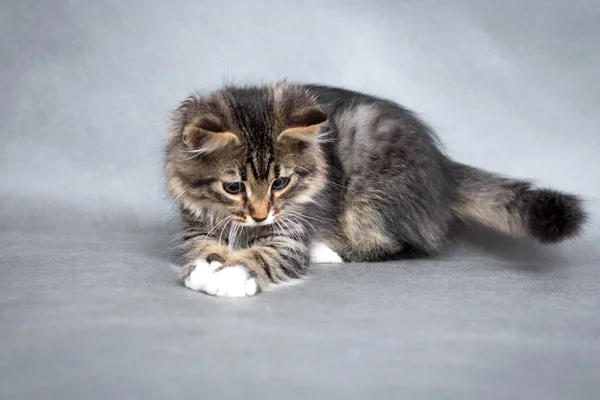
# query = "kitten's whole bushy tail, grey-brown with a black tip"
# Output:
<box><xmin>450</xmin><ymin>162</ymin><xmax>587</xmax><ymax>243</ymax></box>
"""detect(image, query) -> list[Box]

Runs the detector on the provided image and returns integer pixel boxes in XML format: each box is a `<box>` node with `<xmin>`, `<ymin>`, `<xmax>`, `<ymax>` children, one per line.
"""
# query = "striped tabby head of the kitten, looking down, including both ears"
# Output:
<box><xmin>165</xmin><ymin>83</ymin><xmax>327</xmax><ymax>226</ymax></box>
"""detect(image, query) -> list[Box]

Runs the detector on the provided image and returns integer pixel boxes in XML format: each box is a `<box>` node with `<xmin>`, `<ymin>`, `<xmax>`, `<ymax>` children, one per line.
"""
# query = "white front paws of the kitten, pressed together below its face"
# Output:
<box><xmin>183</xmin><ymin>259</ymin><xmax>258</xmax><ymax>297</ymax></box>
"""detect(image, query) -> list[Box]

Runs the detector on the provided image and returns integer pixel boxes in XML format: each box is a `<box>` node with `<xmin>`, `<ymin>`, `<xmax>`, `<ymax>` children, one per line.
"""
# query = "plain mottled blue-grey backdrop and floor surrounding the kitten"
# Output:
<box><xmin>0</xmin><ymin>0</ymin><xmax>600</xmax><ymax>399</ymax></box>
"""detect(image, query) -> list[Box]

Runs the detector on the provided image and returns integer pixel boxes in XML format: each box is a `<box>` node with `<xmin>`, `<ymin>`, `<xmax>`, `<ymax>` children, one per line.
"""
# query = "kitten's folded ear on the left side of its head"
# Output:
<box><xmin>183</xmin><ymin>117</ymin><xmax>240</xmax><ymax>153</ymax></box>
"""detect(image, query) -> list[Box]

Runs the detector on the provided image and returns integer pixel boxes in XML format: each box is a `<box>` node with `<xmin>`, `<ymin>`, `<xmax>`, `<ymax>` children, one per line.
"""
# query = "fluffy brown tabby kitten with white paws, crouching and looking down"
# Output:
<box><xmin>165</xmin><ymin>82</ymin><xmax>586</xmax><ymax>296</ymax></box>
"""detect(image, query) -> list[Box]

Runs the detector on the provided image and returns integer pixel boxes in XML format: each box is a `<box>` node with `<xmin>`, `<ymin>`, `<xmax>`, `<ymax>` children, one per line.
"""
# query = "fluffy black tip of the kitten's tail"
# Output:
<box><xmin>525</xmin><ymin>189</ymin><xmax>587</xmax><ymax>244</ymax></box>
